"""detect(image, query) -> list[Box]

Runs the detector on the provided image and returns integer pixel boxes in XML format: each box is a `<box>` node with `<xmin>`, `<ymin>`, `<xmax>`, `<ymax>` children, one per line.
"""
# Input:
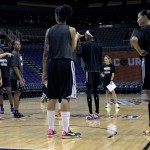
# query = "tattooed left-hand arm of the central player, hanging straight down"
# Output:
<box><xmin>42</xmin><ymin>29</ymin><xmax>49</xmax><ymax>82</ymax></box>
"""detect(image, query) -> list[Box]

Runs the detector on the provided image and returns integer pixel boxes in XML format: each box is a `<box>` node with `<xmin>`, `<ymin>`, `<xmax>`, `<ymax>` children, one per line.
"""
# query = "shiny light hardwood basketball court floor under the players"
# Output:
<box><xmin>0</xmin><ymin>94</ymin><xmax>150</xmax><ymax>150</ymax></box>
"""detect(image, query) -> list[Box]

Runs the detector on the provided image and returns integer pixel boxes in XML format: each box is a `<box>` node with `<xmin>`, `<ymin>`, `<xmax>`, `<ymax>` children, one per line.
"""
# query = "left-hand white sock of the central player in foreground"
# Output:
<box><xmin>47</xmin><ymin>110</ymin><xmax>55</xmax><ymax>130</ymax></box>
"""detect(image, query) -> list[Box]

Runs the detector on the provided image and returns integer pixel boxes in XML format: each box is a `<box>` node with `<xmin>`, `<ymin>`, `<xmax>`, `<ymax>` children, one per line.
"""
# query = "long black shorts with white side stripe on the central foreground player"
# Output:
<box><xmin>47</xmin><ymin>59</ymin><xmax>76</xmax><ymax>99</ymax></box>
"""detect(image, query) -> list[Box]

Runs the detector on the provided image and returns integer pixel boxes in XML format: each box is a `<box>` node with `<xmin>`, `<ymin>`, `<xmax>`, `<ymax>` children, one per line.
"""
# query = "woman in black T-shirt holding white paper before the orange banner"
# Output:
<box><xmin>101</xmin><ymin>55</ymin><xmax>120</xmax><ymax>109</ymax></box>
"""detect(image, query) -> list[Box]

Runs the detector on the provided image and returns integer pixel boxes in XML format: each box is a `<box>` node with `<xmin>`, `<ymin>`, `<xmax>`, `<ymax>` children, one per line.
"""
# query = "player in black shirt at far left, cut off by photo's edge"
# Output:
<box><xmin>0</xmin><ymin>48</ymin><xmax>14</xmax><ymax>114</ymax></box>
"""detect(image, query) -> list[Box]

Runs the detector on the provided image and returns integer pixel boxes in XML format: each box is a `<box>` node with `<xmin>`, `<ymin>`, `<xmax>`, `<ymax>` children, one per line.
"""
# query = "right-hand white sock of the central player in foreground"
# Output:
<box><xmin>61</xmin><ymin>112</ymin><xmax>70</xmax><ymax>132</ymax></box>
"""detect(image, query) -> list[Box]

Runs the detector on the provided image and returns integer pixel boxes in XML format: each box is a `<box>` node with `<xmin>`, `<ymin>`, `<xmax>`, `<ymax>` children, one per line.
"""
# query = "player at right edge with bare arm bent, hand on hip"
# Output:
<box><xmin>131</xmin><ymin>10</ymin><xmax>150</xmax><ymax>132</ymax></box>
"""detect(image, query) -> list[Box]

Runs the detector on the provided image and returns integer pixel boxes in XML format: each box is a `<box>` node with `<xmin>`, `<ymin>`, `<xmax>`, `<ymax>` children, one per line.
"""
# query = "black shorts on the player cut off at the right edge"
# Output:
<box><xmin>143</xmin><ymin>54</ymin><xmax>150</xmax><ymax>90</ymax></box>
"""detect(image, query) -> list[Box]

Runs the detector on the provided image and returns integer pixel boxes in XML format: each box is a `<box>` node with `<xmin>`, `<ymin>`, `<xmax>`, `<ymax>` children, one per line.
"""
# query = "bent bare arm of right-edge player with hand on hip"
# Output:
<box><xmin>130</xmin><ymin>36</ymin><xmax>147</xmax><ymax>56</ymax></box>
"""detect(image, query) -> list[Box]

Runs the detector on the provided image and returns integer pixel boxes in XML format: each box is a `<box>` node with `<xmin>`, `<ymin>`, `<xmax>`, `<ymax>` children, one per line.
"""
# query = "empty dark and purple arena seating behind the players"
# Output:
<box><xmin>1</xmin><ymin>25</ymin><xmax>141</xmax><ymax>97</ymax></box>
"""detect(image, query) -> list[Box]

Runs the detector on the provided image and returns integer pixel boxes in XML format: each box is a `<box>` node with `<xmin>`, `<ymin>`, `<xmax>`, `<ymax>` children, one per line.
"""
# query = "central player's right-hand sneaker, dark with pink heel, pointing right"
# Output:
<box><xmin>61</xmin><ymin>131</ymin><xmax>81</xmax><ymax>139</ymax></box>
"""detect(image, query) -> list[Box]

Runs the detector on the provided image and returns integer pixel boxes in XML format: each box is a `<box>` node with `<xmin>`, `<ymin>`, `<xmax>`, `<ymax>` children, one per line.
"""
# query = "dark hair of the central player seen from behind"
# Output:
<box><xmin>55</xmin><ymin>5</ymin><xmax>73</xmax><ymax>21</ymax></box>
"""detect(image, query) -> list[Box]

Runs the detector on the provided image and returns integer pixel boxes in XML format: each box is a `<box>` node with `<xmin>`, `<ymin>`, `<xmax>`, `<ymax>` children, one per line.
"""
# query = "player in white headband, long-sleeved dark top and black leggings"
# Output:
<box><xmin>78</xmin><ymin>30</ymin><xmax>102</xmax><ymax>120</ymax></box>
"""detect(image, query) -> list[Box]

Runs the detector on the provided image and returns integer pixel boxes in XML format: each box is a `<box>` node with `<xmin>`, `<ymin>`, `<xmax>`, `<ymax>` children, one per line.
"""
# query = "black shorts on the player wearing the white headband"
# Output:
<box><xmin>86</xmin><ymin>72</ymin><xmax>100</xmax><ymax>86</ymax></box>
